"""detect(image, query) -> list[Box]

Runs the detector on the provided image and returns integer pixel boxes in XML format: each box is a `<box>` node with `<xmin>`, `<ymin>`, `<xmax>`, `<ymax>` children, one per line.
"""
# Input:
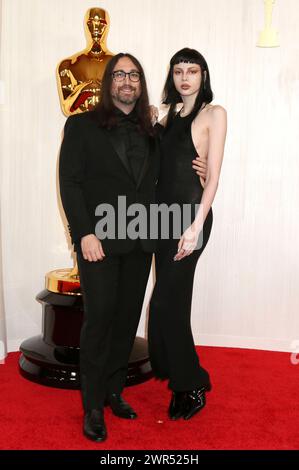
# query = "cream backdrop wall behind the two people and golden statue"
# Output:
<box><xmin>0</xmin><ymin>0</ymin><xmax>299</xmax><ymax>350</ymax></box>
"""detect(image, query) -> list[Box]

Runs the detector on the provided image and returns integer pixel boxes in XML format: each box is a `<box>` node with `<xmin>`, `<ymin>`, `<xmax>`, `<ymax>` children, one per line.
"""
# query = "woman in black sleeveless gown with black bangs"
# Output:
<box><xmin>148</xmin><ymin>48</ymin><xmax>226</xmax><ymax>419</ymax></box>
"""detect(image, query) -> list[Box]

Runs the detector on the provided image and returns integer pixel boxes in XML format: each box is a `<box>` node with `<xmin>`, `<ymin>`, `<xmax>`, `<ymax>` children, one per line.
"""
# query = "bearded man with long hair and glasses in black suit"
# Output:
<box><xmin>59</xmin><ymin>54</ymin><xmax>207</xmax><ymax>442</ymax></box>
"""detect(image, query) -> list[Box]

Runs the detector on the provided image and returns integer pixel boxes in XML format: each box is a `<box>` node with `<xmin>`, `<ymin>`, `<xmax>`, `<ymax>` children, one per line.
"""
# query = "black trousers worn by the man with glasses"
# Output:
<box><xmin>77</xmin><ymin>240</ymin><xmax>152</xmax><ymax>411</ymax></box>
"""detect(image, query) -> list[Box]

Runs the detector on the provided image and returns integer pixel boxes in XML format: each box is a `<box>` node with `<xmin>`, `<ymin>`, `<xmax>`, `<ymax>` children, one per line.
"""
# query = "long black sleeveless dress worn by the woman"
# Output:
<box><xmin>148</xmin><ymin>114</ymin><xmax>213</xmax><ymax>392</ymax></box>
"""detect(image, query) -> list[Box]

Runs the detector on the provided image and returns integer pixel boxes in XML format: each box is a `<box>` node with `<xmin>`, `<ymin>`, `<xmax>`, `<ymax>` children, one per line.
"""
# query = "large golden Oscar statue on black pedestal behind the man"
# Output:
<box><xmin>19</xmin><ymin>8</ymin><xmax>152</xmax><ymax>388</ymax></box>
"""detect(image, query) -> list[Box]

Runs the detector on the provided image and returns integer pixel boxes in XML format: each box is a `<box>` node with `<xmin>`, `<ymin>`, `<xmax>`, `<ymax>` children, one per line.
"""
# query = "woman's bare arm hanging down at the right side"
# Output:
<box><xmin>174</xmin><ymin>105</ymin><xmax>227</xmax><ymax>261</ymax></box>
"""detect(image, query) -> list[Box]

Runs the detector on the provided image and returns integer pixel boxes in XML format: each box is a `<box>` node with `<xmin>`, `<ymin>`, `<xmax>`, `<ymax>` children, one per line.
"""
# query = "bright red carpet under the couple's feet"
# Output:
<box><xmin>0</xmin><ymin>347</ymin><xmax>299</xmax><ymax>450</ymax></box>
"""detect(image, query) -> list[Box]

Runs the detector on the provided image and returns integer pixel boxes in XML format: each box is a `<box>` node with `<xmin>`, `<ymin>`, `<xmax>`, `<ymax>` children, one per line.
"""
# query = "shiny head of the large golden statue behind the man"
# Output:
<box><xmin>84</xmin><ymin>8</ymin><xmax>110</xmax><ymax>42</ymax></box>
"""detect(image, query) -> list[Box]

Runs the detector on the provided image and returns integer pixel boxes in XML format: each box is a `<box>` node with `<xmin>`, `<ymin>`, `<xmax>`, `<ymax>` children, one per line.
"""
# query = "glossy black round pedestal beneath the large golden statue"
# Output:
<box><xmin>19</xmin><ymin>289</ymin><xmax>152</xmax><ymax>389</ymax></box>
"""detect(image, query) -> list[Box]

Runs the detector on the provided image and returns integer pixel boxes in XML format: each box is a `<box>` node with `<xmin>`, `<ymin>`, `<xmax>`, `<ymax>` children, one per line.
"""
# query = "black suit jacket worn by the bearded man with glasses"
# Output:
<box><xmin>59</xmin><ymin>112</ymin><xmax>160</xmax><ymax>254</ymax></box>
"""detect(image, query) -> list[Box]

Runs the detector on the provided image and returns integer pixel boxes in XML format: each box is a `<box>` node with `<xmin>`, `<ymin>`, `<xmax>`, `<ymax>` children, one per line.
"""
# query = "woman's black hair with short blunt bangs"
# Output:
<box><xmin>162</xmin><ymin>47</ymin><xmax>213</xmax><ymax>128</ymax></box>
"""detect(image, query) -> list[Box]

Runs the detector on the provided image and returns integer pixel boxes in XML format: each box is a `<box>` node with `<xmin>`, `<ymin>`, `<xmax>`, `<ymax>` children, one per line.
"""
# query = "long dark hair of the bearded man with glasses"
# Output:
<box><xmin>92</xmin><ymin>52</ymin><xmax>154</xmax><ymax>135</ymax></box>
